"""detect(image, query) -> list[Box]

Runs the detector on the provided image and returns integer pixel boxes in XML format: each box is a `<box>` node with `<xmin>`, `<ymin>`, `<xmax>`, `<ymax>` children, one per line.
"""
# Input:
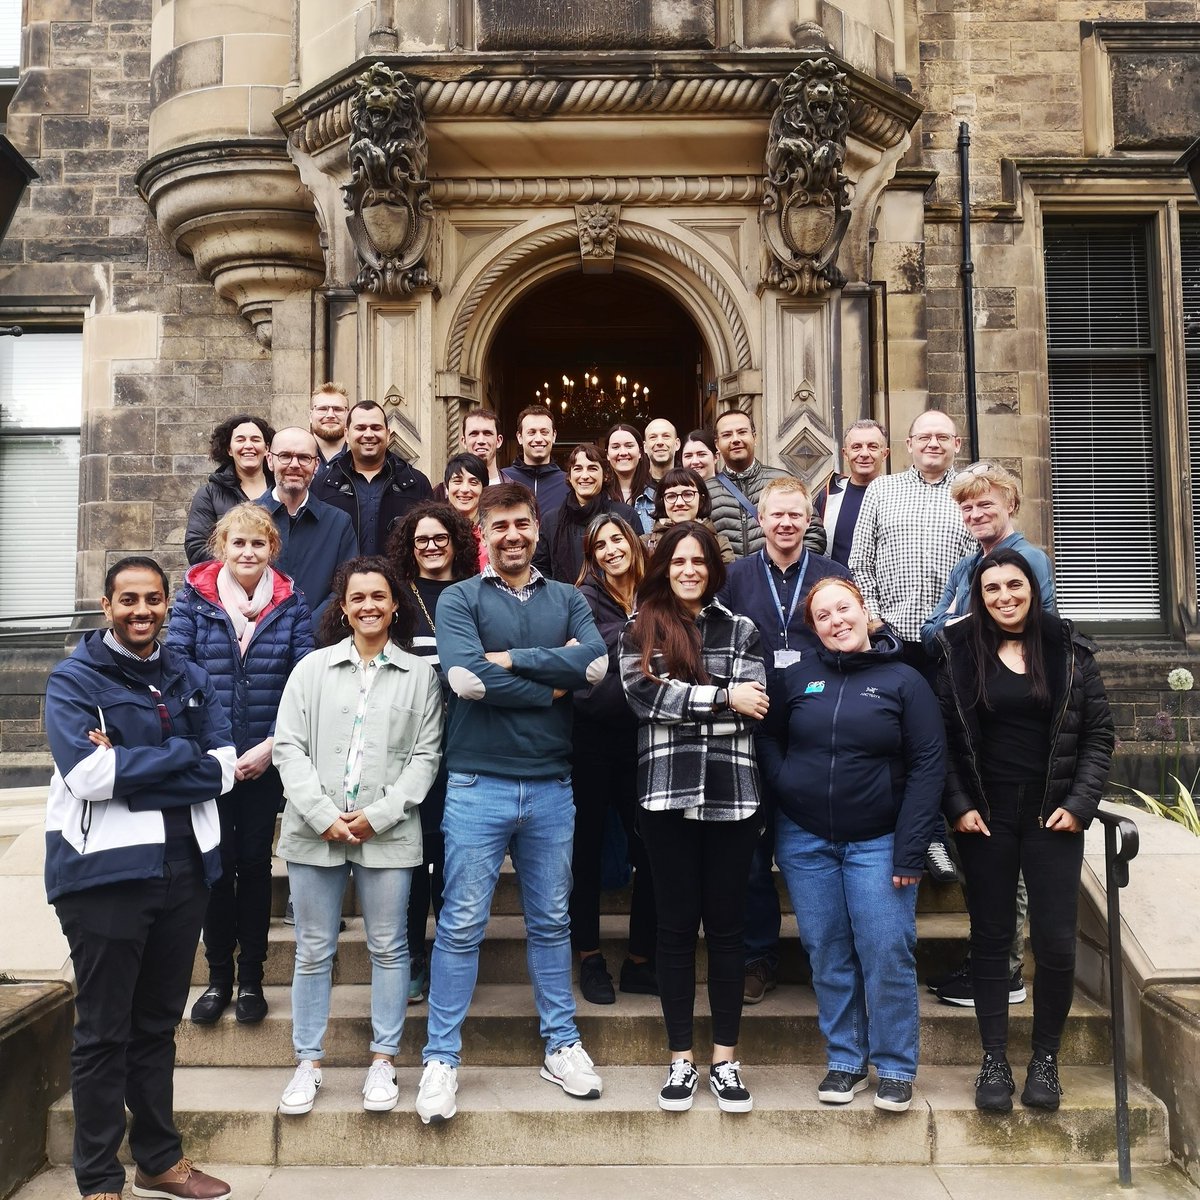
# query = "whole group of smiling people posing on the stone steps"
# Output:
<box><xmin>47</xmin><ymin>393</ymin><xmax>1114</xmax><ymax>1200</ymax></box>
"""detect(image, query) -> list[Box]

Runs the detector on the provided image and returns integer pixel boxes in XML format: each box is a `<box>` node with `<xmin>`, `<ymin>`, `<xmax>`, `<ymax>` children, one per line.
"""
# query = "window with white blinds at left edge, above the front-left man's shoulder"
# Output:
<box><xmin>0</xmin><ymin>330</ymin><xmax>83</xmax><ymax>622</ymax></box>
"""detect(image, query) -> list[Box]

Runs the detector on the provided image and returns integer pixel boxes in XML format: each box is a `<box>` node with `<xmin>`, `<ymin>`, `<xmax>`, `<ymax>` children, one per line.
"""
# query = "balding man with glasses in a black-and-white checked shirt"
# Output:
<box><xmin>850</xmin><ymin>408</ymin><xmax>976</xmax><ymax>882</ymax></box>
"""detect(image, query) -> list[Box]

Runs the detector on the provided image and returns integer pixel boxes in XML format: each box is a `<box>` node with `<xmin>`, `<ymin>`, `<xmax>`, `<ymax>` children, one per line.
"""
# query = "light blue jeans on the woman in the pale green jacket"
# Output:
<box><xmin>288</xmin><ymin>863</ymin><xmax>413</xmax><ymax>1061</ymax></box>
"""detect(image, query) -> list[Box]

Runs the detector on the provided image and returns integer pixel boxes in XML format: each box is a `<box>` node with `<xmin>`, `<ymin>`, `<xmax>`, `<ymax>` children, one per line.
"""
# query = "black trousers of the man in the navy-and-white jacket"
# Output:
<box><xmin>54</xmin><ymin>854</ymin><xmax>209</xmax><ymax>1195</ymax></box>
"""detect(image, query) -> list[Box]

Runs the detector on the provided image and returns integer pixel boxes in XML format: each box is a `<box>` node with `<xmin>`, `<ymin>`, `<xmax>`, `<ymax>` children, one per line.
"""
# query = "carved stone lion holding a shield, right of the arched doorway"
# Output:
<box><xmin>762</xmin><ymin>58</ymin><xmax>850</xmax><ymax>295</ymax></box>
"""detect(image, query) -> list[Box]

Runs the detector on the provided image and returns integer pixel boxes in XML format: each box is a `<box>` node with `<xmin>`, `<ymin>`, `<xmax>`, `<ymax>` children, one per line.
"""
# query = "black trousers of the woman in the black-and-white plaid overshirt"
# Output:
<box><xmin>638</xmin><ymin>809</ymin><xmax>762</xmax><ymax>1052</ymax></box>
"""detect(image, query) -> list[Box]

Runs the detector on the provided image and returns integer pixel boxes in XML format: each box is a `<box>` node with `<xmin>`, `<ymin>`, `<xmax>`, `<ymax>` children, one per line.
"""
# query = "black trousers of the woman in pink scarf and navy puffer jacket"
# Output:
<box><xmin>204</xmin><ymin>767</ymin><xmax>283</xmax><ymax>985</ymax></box>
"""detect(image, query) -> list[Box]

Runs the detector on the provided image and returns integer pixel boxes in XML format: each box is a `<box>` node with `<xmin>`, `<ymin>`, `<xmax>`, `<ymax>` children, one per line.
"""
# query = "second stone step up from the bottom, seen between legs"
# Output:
<box><xmin>176</xmin><ymin>984</ymin><xmax>1111</xmax><ymax>1069</ymax></box>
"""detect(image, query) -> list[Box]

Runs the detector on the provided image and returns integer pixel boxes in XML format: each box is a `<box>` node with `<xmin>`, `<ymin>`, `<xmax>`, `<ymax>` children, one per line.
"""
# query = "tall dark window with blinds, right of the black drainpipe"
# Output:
<box><xmin>1043</xmin><ymin>218</ymin><xmax>1163</xmax><ymax>631</ymax></box>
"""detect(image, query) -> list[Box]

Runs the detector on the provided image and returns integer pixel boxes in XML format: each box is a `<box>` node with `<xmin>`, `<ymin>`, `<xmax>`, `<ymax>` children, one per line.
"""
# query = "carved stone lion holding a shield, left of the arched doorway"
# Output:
<box><xmin>342</xmin><ymin>62</ymin><xmax>433</xmax><ymax>295</ymax></box>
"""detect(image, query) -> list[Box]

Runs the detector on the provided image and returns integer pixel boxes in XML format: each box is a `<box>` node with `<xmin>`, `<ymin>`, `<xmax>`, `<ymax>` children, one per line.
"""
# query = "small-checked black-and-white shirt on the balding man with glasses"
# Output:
<box><xmin>850</xmin><ymin>467</ymin><xmax>978</xmax><ymax>642</ymax></box>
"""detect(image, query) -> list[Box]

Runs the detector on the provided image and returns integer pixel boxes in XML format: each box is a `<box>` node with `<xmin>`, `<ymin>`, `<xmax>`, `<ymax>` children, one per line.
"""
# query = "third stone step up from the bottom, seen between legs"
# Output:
<box><xmin>192</xmin><ymin>912</ymin><xmax>967</xmax><ymax>986</ymax></box>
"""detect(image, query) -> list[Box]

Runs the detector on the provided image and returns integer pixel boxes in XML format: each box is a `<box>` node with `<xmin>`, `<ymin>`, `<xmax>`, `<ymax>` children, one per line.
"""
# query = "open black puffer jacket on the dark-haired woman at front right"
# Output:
<box><xmin>937</xmin><ymin>614</ymin><xmax>1115</xmax><ymax>827</ymax></box>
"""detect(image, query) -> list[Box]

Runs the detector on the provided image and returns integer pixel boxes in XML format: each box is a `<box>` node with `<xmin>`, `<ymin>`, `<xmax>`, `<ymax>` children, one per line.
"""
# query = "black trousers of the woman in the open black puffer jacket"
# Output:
<box><xmin>955</xmin><ymin>780</ymin><xmax>1084</xmax><ymax>1055</ymax></box>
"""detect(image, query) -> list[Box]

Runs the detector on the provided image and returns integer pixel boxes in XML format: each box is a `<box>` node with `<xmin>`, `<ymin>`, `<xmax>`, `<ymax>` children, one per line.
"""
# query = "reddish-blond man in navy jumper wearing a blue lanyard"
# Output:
<box><xmin>719</xmin><ymin>475</ymin><xmax>850</xmax><ymax>1004</ymax></box>
